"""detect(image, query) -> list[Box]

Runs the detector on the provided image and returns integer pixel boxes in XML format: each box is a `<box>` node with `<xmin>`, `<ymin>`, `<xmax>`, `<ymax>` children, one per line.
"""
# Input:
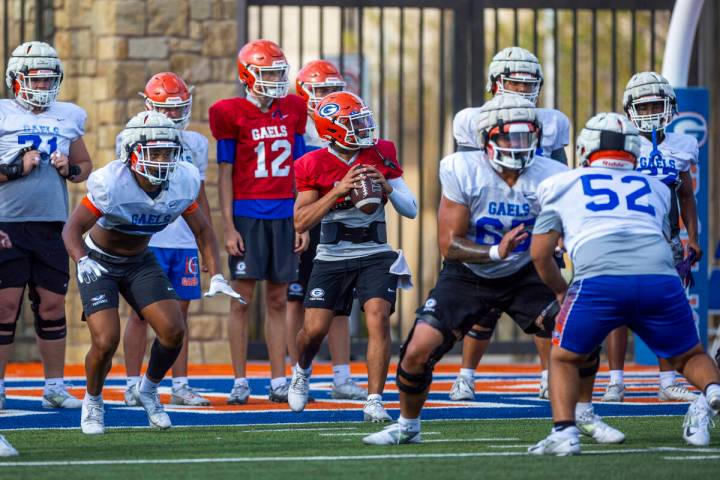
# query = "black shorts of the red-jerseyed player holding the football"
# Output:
<box><xmin>303</xmin><ymin>252</ymin><xmax>398</xmax><ymax>316</ymax></box>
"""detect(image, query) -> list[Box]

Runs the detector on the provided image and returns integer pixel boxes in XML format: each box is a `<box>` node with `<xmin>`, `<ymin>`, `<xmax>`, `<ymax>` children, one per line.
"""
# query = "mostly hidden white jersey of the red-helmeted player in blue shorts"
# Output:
<box><xmin>115</xmin><ymin>130</ymin><xmax>208</xmax><ymax>249</ymax></box>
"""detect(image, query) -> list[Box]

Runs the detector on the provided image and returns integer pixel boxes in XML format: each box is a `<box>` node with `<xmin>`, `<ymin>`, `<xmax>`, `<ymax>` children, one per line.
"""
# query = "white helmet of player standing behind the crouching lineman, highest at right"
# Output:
<box><xmin>485</xmin><ymin>47</ymin><xmax>543</xmax><ymax>103</ymax></box>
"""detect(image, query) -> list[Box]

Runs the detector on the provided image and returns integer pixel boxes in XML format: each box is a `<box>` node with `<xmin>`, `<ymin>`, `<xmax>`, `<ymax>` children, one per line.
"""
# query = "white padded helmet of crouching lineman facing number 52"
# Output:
<box><xmin>474</xmin><ymin>95</ymin><xmax>542</xmax><ymax>172</ymax></box>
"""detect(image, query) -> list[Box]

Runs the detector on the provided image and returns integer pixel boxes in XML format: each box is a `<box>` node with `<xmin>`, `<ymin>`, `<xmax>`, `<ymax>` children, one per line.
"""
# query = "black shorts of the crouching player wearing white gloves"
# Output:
<box><xmin>78</xmin><ymin>249</ymin><xmax>180</xmax><ymax>316</ymax></box>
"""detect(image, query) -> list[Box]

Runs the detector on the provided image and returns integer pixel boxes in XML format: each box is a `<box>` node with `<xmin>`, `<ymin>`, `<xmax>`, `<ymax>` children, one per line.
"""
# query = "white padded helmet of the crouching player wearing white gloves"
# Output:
<box><xmin>120</xmin><ymin>110</ymin><xmax>182</xmax><ymax>185</ymax></box>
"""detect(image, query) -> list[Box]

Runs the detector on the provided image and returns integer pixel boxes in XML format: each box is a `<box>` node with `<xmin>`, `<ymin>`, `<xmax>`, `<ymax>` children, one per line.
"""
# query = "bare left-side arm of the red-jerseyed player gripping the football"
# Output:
<box><xmin>295</xmin><ymin>165</ymin><xmax>367</xmax><ymax>233</ymax></box>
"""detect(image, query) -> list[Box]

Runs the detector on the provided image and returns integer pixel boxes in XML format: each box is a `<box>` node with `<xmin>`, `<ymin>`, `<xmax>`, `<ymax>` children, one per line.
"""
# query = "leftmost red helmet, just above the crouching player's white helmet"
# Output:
<box><xmin>140</xmin><ymin>72</ymin><xmax>193</xmax><ymax>129</ymax></box>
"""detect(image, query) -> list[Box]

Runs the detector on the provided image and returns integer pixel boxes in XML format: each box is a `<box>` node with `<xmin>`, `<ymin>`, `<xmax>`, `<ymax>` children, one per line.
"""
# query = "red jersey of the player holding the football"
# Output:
<box><xmin>295</xmin><ymin>140</ymin><xmax>403</xmax><ymax>207</ymax></box>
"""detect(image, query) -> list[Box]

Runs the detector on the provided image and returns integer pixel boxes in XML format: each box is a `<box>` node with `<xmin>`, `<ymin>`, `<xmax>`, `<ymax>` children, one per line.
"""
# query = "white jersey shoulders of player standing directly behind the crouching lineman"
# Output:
<box><xmin>453</xmin><ymin>107</ymin><xmax>570</xmax><ymax>157</ymax></box>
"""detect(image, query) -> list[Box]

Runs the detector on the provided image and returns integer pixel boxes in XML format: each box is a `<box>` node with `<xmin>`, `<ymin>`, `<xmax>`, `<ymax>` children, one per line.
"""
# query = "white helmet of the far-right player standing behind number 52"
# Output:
<box><xmin>623</xmin><ymin>72</ymin><xmax>677</xmax><ymax>132</ymax></box>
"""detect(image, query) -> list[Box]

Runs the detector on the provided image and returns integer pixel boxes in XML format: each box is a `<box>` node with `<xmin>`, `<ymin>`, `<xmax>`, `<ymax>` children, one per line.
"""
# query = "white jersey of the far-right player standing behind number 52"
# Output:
<box><xmin>636</xmin><ymin>132</ymin><xmax>699</xmax><ymax>187</ymax></box>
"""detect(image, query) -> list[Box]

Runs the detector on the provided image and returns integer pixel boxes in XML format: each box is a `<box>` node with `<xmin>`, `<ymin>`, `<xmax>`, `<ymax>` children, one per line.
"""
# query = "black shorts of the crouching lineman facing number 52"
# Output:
<box><xmin>416</xmin><ymin>262</ymin><xmax>555</xmax><ymax>340</ymax></box>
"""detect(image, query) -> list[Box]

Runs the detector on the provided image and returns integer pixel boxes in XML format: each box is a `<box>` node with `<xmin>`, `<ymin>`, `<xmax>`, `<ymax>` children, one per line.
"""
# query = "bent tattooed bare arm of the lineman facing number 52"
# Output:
<box><xmin>438</xmin><ymin>196</ymin><xmax>528</xmax><ymax>263</ymax></box>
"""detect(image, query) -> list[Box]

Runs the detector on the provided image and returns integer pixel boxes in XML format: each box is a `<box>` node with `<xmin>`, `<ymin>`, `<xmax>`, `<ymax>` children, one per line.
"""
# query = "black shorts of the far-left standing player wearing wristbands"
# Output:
<box><xmin>0</xmin><ymin>220</ymin><xmax>70</xmax><ymax>295</ymax></box>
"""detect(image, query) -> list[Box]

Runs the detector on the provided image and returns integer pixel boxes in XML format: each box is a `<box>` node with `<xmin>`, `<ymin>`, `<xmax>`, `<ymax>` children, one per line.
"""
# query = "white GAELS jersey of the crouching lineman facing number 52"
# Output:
<box><xmin>440</xmin><ymin>150</ymin><xmax>567</xmax><ymax>278</ymax></box>
